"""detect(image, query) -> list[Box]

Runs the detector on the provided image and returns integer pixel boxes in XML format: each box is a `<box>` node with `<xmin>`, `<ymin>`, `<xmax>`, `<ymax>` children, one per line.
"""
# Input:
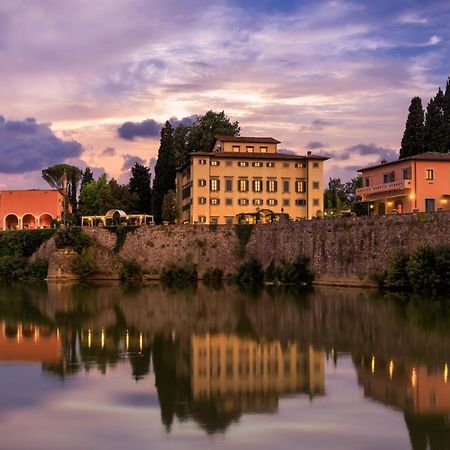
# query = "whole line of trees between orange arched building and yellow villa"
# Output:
<box><xmin>42</xmin><ymin>111</ymin><xmax>240</xmax><ymax>225</ymax></box>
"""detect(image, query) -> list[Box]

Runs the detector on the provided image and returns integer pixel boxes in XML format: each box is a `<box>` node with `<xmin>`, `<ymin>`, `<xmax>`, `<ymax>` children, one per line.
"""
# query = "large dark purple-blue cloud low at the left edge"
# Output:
<box><xmin>0</xmin><ymin>116</ymin><xmax>83</xmax><ymax>174</ymax></box>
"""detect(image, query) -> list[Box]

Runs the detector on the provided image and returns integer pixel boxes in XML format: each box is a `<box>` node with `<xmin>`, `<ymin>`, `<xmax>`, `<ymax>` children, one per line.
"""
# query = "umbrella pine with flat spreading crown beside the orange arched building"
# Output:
<box><xmin>42</xmin><ymin>164</ymin><xmax>82</xmax><ymax>221</ymax></box>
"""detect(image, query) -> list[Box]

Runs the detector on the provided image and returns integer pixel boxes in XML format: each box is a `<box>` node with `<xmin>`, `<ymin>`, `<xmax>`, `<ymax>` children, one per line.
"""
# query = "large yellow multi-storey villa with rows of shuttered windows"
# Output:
<box><xmin>177</xmin><ymin>136</ymin><xmax>328</xmax><ymax>224</ymax></box>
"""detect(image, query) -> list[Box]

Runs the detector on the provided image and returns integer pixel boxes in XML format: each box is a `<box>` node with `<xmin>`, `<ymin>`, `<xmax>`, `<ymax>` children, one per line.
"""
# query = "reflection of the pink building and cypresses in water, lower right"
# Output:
<box><xmin>354</xmin><ymin>355</ymin><xmax>450</xmax><ymax>450</ymax></box>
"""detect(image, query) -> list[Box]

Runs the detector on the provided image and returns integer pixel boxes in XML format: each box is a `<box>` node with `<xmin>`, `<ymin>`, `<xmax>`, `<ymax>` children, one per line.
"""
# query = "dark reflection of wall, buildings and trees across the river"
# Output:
<box><xmin>0</xmin><ymin>285</ymin><xmax>450</xmax><ymax>449</ymax></box>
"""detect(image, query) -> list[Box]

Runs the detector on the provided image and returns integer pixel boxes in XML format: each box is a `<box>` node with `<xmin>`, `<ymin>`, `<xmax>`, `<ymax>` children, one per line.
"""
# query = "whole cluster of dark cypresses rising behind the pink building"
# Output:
<box><xmin>400</xmin><ymin>78</ymin><xmax>450</xmax><ymax>159</ymax></box>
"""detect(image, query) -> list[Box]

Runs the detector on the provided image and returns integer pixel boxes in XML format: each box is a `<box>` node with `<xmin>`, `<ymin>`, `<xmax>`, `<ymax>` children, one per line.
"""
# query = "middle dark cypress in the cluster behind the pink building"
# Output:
<box><xmin>424</xmin><ymin>88</ymin><xmax>447</xmax><ymax>153</ymax></box>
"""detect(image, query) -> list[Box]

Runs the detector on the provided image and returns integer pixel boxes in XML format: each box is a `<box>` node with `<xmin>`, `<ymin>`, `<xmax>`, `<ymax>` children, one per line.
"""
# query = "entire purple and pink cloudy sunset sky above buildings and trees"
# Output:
<box><xmin>0</xmin><ymin>0</ymin><xmax>450</xmax><ymax>189</ymax></box>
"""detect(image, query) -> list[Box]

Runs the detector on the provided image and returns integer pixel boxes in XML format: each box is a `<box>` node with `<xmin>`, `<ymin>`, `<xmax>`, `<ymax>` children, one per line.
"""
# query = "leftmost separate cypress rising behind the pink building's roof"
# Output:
<box><xmin>400</xmin><ymin>97</ymin><xmax>424</xmax><ymax>159</ymax></box>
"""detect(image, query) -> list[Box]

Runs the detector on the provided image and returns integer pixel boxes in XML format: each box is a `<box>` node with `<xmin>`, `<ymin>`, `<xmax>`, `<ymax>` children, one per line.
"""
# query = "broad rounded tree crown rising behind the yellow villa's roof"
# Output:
<box><xmin>188</xmin><ymin>111</ymin><xmax>241</xmax><ymax>152</ymax></box>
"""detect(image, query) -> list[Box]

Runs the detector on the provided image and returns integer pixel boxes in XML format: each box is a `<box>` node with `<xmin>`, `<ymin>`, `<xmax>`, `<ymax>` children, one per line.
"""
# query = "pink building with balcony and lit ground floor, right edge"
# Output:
<box><xmin>356</xmin><ymin>152</ymin><xmax>450</xmax><ymax>215</ymax></box>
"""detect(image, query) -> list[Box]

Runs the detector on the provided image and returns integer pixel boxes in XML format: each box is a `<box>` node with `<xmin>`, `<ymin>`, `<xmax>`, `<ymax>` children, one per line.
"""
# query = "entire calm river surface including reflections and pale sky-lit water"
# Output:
<box><xmin>0</xmin><ymin>284</ymin><xmax>450</xmax><ymax>450</ymax></box>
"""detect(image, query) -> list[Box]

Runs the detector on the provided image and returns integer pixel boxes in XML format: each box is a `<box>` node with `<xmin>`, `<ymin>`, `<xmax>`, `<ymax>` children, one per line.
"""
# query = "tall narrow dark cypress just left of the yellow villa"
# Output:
<box><xmin>152</xmin><ymin>121</ymin><xmax>176</xmax><ymax>223</ymax></box>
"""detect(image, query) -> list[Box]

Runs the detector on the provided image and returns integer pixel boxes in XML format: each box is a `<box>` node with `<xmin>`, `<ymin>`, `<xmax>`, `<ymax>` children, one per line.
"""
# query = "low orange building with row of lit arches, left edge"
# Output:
<box><xmin>0</xmin><ymin>189</ymin><xmax>63</xmax><ymax>230</ymax></box>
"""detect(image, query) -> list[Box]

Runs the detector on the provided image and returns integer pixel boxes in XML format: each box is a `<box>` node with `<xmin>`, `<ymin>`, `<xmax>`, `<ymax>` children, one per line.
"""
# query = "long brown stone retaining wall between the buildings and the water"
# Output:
<box><xmin>45</xmin><ymin>212</ymin><xmax>450</xmax><ymax>285</ymax></box>
